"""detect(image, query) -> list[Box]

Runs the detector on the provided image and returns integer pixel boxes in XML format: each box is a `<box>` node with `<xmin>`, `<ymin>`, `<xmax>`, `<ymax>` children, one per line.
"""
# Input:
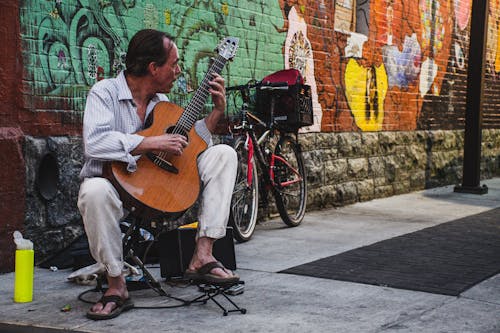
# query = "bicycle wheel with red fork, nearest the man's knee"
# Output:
<box><xmin>229</xmin><ymin>137</ymin><xmax>259</xmax><ymax>242</ymax></box>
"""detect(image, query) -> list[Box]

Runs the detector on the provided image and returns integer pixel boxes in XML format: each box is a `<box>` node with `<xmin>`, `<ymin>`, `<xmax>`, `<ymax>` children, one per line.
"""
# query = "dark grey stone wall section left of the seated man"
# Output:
<box><xmin>23</xmin><ymin>136</ymin><xmax>83</xmax><ymax>261</ymax></box>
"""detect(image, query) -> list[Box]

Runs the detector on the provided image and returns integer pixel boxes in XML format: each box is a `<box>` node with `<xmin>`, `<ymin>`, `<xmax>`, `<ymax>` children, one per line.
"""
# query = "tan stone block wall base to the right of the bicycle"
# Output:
<box><xmin>300</xmin><ymin>129</ymin><xmax>500</xmax><ymax>209</ymax></box>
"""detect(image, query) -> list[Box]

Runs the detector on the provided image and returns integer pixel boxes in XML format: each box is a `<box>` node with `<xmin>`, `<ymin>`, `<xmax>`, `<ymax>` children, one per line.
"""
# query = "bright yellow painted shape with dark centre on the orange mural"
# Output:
<box><xmin>345</xmin><ymin>59</ymin><xmax>389</xmax><ymax>132</ymax></box>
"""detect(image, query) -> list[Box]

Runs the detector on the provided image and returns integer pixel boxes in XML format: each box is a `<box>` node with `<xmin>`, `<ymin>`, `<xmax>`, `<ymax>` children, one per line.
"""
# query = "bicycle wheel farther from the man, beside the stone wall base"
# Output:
<box><xmin>273</xmin><ymin>136</ymin><xmax>307</xmax><ymax>227</ymax></box>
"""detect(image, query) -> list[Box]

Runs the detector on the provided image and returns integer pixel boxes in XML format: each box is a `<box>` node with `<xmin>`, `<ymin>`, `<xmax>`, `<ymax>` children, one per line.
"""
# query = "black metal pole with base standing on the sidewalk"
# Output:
<box><xmin>455</xmin><ymin>0</ymin><xmax>488</xmax><ymax>194</ymax></box>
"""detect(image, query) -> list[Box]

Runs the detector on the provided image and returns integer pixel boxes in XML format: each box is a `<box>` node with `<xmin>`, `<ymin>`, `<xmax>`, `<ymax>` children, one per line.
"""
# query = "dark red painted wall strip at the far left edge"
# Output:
<box><xmin>0</xmin><ymin>0</ymin><xmax>25</xmax><ymax>272</ymax></box>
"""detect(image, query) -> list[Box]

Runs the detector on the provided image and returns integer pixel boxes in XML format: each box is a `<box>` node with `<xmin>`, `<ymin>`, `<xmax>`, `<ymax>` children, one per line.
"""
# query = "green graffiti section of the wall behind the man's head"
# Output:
<box><xmin>20</xmin><ymin>0</ymin><xmax>286</xmax><ymax>111</ymax></box>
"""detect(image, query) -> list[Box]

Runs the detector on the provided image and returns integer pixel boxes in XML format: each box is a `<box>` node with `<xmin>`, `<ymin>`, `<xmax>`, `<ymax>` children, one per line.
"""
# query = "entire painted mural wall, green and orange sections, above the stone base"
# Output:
<box><xmin>20</xmin><ymin>0</ymin><xmax>500</xmax><ymax>132</ymax></box>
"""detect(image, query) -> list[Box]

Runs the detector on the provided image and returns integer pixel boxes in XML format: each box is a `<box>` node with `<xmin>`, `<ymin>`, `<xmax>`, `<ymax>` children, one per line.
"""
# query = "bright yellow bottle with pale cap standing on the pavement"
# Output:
<box><xmin>14</xmin><ymin>231</ymin><xmax>35</xmax><ymax>303</ymax></box>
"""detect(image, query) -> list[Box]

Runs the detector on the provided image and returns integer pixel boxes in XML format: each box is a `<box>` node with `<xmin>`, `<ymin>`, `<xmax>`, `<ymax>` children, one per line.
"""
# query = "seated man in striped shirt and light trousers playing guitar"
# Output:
<box><xmin>78</xmin><ymin>29</ymin><xmax>239</xmax><ymax>320</ymax></box>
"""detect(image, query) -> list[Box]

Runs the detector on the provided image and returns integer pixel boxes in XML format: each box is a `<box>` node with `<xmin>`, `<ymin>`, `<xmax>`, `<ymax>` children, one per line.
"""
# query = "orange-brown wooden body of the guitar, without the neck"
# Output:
<box><xmin>108</xmin><ymin>102</ymin><xmax>207</xmax><ymax>218</ymax></box>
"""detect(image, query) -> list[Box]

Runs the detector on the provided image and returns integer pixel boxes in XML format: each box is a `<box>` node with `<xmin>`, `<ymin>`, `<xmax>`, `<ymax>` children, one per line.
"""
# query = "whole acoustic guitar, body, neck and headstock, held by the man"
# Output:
<box><xmin>107</xmin><ymin>37</ymin><xmax>238</xmax><ymax>218</ymax></box>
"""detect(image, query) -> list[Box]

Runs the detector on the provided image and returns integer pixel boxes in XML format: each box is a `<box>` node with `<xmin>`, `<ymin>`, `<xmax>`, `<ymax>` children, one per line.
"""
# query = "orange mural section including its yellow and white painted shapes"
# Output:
<box><xmin>280</xmin><ymin>0</ymin><xmax>499</xmax><ymax>131</ymax></box>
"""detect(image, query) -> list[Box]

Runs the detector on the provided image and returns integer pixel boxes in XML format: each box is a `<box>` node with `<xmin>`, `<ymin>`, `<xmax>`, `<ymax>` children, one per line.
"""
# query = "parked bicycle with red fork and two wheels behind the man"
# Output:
<box><xmin>226</xmin><ymin>74</ymin><xmax>312</xmax><ymax>242</ymax></box>
